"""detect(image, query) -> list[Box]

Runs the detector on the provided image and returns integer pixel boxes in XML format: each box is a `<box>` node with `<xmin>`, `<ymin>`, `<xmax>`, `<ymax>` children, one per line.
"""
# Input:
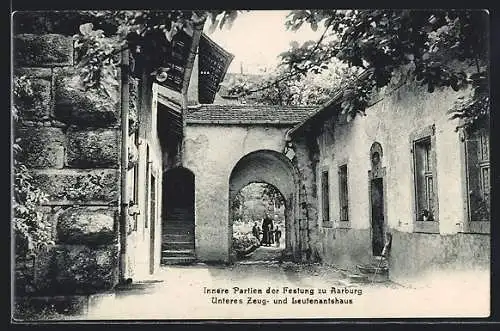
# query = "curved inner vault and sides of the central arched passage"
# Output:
<box><xmin>228</xmin><ymin>150</ymin><xmax>298</xmax><ymax>262</ymax></box>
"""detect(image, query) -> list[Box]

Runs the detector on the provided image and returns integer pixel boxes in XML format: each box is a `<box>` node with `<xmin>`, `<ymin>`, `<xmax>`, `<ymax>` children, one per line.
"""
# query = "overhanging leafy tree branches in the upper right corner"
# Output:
<box><xmin>281</xmin><ymin>10</ymin><xmax>489</xmax><ymax>128</ymax></box>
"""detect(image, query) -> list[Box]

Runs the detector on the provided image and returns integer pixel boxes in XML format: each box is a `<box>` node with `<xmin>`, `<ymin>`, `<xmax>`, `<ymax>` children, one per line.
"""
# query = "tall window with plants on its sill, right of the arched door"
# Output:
<box><xmin>412</xmin><ymin>126</ymin><xmax>439</xmax><ymax>232</ymax></box>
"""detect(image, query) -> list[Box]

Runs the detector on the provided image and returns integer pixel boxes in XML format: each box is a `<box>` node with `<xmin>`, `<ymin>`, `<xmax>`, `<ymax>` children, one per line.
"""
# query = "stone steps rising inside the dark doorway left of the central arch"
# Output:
<box><xmin>161</xmin><ymin>208</ymin><xmax>196</xmax><ymax>264</ymax></box>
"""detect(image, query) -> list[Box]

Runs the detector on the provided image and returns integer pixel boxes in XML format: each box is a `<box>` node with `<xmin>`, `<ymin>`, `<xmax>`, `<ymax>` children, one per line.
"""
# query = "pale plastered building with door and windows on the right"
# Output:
<box><xmin>288</xmin><ymin>69</ymin><xmax>490</xmax><ymax>280</ymax></box>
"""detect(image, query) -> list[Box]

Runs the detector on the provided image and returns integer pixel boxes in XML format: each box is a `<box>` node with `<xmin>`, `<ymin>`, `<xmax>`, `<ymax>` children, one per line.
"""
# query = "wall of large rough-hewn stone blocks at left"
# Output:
<box><xmin>13</xmin><ymin>29</ymin><xmax>120</xmax><ymax>294</ymax></box>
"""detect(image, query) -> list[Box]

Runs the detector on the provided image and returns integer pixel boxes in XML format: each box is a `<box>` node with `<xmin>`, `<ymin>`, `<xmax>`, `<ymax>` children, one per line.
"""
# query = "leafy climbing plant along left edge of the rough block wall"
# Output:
<box><xmin>12</xmin><ymin>76</ymin><xmax>53</xmax><ymax>258</ymax></box>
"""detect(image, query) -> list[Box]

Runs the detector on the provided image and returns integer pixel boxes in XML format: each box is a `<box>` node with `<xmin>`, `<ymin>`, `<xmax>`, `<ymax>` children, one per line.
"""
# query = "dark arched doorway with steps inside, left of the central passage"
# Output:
<box><xmin>161</xmin><ymin>167</ymin><xmax>195</xmax><ymax>264</ymax></box>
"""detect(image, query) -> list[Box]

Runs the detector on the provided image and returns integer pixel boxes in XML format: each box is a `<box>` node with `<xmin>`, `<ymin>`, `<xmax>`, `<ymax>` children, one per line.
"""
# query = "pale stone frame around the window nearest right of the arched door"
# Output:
<box><xmin>409</xmin><ymin>124</ymin><xmax>439</xmax><ymax>233</ymax></box>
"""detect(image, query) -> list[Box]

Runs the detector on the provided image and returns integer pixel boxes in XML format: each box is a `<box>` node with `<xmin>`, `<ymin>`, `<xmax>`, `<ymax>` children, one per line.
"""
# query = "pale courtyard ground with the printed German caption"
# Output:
<box><xmin>14</xmin><ymin>247</ymin><xmax>490</xmax><ymax>321</ymax></box>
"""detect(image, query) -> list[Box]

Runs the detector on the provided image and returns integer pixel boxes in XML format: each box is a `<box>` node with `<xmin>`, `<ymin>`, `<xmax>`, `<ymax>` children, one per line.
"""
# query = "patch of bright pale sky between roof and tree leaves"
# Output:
<box><xmin>205</xmin><ymin>10</ymin><xmax>323</xmax><ymax>74</ymax></box>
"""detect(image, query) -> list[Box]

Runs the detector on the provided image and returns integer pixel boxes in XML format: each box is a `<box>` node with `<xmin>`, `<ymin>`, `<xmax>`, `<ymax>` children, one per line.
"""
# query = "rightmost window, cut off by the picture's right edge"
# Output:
<box><xmin>465</xmin><ymin>128</ymin><xmax>491</xmax><ymax>233</ymax></box>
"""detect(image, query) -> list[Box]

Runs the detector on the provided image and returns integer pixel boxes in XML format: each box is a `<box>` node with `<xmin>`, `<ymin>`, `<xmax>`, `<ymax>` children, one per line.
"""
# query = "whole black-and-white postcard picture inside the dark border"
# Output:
<box><xmin>11</xmin><ymin>8</ymin><xmax>491</xmax><ymax>323</ymax></box>
